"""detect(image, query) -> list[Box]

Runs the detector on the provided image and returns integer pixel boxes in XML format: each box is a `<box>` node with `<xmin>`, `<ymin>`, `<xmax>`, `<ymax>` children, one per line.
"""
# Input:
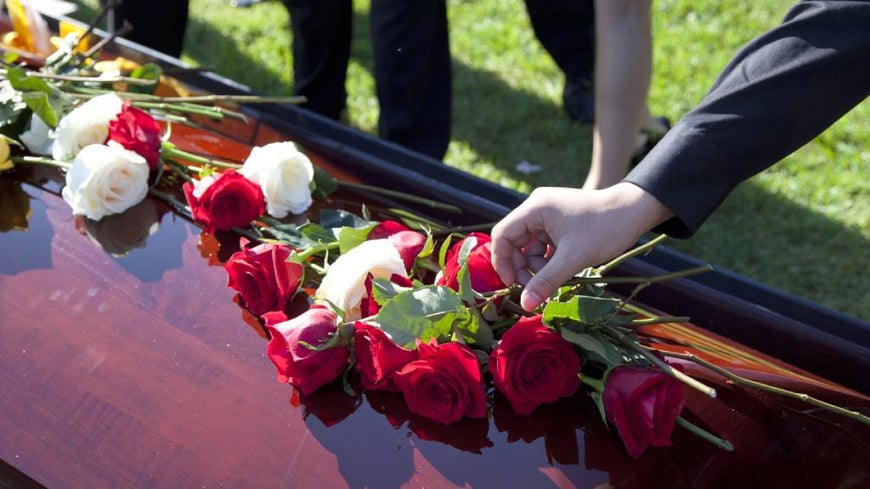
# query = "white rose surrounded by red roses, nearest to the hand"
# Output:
<box><xmin>314</xmin><ymin>239</ymin><xmax>406</xmax><ymax>321</ymax></box>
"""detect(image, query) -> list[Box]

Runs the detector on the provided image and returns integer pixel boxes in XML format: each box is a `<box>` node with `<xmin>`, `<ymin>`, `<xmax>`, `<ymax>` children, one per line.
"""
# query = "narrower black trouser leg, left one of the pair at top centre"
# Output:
<box><xmin>283</xmin><ymin>0</ymin><xmax>353</xmax><ymax>119</ymax></box>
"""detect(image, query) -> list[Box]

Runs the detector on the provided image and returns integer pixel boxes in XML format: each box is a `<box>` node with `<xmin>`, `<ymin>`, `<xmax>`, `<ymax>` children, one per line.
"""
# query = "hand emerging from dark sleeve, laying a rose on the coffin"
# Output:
<box><xmin>492</xmin><ymin>182</ymin><xmax>673</xmax><ymax>311</ymax></box>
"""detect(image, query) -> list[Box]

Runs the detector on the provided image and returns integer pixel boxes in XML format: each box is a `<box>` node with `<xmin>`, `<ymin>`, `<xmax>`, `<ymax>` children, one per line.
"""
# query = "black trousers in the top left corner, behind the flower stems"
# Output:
<box><xmin>100</xmin><ymin>0</ymin><xmax>188</xmax><ymax>58</ymax></box>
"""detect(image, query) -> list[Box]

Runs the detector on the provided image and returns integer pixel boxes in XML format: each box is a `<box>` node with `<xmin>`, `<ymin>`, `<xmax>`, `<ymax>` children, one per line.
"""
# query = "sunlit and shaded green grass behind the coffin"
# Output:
<box><xmin>68</xmin><ymin>0</ymin><xmax>870</xmax><ymax>320</ymax></box>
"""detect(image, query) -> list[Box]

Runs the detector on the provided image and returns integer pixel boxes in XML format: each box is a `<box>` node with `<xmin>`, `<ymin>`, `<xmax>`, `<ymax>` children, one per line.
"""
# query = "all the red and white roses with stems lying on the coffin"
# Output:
<box><xmin>0</xmin><ymin>4</ymin><xmax>870</xmax><ymax>458</ymax></box>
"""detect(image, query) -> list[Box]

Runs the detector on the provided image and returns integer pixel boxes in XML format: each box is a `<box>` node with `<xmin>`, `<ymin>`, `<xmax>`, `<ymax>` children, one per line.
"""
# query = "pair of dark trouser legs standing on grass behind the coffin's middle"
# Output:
<box><xmin>283</xmin><ymin>0</ymin><xmax>452</xmax><ymax>159</ymax></box>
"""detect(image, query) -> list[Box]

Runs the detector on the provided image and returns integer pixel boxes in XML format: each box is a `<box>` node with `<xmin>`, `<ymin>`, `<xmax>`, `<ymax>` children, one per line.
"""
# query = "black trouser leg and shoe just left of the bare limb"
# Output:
<box><xmin>526</xmin><ymin>0</ymin><xmax>595</xmax><ymax>124</ymax></box>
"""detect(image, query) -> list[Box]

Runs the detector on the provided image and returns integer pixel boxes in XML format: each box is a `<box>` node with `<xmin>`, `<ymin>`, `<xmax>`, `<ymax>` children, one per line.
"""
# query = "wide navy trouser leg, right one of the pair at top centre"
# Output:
<box><xmin>370</xmin><ymin>0</ymin><xmax>452</xmax><ymax>159</ymax></box>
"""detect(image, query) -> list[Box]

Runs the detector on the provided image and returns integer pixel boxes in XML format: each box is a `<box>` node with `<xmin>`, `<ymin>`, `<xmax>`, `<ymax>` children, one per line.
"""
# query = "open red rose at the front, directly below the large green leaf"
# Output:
<box><xmin>393</xmin><ymin>343</ymin><xmax>486</xmax><ymax>424</ymax></box>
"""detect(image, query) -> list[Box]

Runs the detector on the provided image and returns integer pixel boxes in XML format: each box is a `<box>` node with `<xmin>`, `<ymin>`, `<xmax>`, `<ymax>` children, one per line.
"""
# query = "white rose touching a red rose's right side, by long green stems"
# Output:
<box><xmin>240</xmin><ymin>142</ymin><xmax>314</xmax><ymax>218</ymax></box>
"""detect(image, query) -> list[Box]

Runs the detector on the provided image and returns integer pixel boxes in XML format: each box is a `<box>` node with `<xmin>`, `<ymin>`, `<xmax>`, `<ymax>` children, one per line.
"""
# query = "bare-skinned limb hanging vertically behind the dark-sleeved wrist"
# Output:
<box><xmin>583</xmin><ymin>0</ymin><xmax>652</xmax><ymax>189</ymax></box>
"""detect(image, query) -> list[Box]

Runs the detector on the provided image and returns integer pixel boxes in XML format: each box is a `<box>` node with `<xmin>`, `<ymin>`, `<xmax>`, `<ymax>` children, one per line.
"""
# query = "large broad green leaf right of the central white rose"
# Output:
<box><xmin>377</xmin><ymin>285</ymin><xmax>468</xmax><ymax>348</ymax></box>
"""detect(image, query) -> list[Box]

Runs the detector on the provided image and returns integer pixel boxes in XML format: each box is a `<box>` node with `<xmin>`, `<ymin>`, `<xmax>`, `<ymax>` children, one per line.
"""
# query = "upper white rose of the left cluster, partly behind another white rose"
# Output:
<box><xmin>52</xmin><ymin>93</ymin><xmax>124</xmax><ymax>161</ymax></box>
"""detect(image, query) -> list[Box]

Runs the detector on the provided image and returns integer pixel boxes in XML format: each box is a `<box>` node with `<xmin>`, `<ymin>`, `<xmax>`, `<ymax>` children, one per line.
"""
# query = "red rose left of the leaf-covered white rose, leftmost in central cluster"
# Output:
<box><xmin>224</xmin><ymin>243</ymin><xmax>303</xmax><ymax>316</ymax></box>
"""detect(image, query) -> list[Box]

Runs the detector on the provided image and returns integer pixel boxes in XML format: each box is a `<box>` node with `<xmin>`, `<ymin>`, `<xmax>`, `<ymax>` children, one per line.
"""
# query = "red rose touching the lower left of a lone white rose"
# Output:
<box><xmin>183</xmin><ymin>170</ymin><xmax>266</xmax><ymax>233</ymax></box>
